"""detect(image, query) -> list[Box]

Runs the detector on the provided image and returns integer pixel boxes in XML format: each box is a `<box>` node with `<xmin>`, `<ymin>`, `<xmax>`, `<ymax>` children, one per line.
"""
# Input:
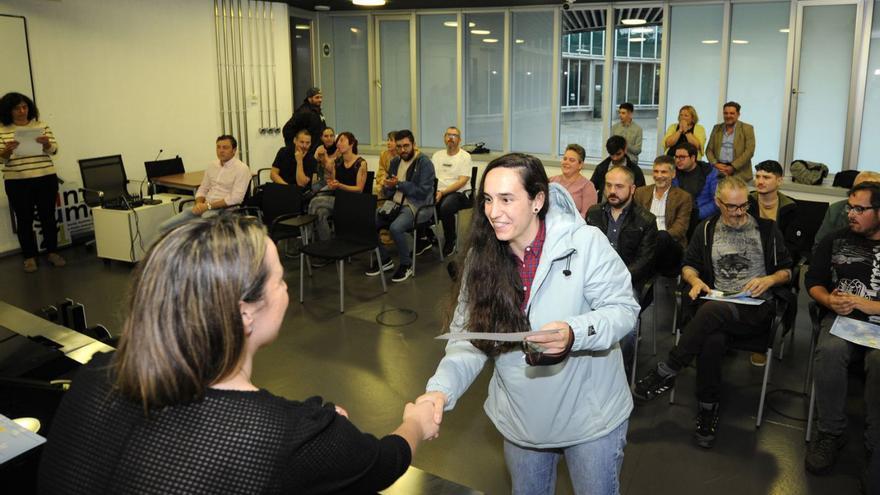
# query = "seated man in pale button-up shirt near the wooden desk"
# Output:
<box><xmin>159</xmin><ymin>134</ymin><xmax>251</xmax><ymax>232</ymax></box>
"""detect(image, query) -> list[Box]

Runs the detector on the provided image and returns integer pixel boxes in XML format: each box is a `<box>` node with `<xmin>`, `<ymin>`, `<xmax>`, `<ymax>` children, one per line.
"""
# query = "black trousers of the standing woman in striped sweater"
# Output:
<box><xmin>4</xmin><ymin>174</ymin><xmax>58</xmax><ymax>258</ymax></box>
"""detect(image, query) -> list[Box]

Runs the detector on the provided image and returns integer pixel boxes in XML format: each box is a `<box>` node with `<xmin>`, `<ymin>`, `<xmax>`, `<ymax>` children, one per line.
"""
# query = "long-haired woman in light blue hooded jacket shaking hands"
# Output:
<box><xmin>418</xmin><ymin>154</ymin><xmax>639</xmax><ymax>495</ymax></box>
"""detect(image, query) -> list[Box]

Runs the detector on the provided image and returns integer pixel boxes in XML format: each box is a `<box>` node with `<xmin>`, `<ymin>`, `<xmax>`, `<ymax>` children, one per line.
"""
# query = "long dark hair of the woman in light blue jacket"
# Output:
<box><xmin>447</xmin><ymin>153</ymin><xmax>550</xmax><ymax>357</ymax></box>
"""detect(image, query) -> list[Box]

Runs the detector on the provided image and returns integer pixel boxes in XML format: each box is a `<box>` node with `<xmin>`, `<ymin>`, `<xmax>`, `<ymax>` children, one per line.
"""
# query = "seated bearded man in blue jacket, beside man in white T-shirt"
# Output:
<box><xmin>365</xmin><ymin>129</ymin><xmax>435</xmax><ymax>282</ymax></box>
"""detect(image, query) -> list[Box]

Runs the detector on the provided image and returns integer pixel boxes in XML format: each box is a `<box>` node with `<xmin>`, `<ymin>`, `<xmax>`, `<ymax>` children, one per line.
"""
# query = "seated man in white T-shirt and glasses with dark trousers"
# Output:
<box><xmin>426</xmin><ymin>127</ymin><xmax>473</xmax><ymax>256</ymax></box>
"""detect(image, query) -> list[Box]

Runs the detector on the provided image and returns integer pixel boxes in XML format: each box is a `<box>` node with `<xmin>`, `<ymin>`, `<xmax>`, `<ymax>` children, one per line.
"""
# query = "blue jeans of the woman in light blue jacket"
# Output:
<box><xmin>504</xmin><ymin>421</ymin><xmax>629</xmax><ymax>495</ymax></box>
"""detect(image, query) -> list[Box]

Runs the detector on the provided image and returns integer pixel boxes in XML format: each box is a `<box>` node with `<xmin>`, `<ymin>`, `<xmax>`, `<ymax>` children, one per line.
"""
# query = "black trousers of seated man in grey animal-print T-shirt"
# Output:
<box><xmin>667</xmin><ymin>294</ymin><xmax>776</xmax><ymax>402</ymax></box>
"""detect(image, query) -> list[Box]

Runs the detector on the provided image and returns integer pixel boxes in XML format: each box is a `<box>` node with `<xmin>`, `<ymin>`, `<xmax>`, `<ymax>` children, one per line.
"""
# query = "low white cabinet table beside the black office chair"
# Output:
<box><xmin>92</xmin><ymin>194</ymin><xmax>183</xmax><ymax>263</ymax></box>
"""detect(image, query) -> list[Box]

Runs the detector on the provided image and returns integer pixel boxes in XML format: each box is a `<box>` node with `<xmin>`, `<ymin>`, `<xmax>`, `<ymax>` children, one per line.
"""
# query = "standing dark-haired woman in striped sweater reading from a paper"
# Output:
<box><xmin>0</xmin><ymin>93</ymin><xmax>66</xmax><ymax>273</ymax></box>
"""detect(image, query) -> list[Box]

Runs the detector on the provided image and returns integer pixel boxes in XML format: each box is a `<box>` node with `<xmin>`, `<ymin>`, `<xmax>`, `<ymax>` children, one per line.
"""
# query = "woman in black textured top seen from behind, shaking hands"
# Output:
<box><xmin>39</xmin><ymin>215</ymin><xmax>437</xmax><ymax>494</ymax></box>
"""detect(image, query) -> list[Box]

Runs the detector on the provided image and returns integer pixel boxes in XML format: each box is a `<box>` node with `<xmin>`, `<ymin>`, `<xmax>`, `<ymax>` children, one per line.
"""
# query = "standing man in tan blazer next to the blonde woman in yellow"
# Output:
<box><xmin>706</xmin><ymin>101</ymin><xmax>755</xmax><ymax>182</ymax></box>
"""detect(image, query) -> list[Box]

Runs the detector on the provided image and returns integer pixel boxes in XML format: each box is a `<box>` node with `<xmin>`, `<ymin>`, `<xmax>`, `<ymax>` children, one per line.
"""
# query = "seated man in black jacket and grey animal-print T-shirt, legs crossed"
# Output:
<box><xmin>633</xmin><ymin>177</ymin><xmax>792</xmax><ymax>448</ymax></box>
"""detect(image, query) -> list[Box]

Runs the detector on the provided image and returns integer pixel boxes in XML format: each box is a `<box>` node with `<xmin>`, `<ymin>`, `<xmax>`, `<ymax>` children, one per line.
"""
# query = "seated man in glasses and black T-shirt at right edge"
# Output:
<box><xmin>804</xmin><ymin>182</ymin><xmax>880</xmax><ymax>480</ymax></box>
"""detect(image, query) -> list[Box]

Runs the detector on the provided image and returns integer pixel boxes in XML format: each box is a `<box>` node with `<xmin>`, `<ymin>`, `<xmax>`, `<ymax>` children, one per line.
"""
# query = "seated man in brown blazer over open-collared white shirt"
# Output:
<box><xmin>634</xmin><ymin>155</ymin><xmax>694</xmax><ymax>275</ymax></box>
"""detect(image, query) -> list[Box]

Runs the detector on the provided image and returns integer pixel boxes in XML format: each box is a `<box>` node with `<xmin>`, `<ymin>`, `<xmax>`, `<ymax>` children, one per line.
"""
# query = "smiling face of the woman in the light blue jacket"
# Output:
<box><xmin>483</xmin><ymin>167</ymin><xmax>545</xmax><ymax>252</ymax></box>
